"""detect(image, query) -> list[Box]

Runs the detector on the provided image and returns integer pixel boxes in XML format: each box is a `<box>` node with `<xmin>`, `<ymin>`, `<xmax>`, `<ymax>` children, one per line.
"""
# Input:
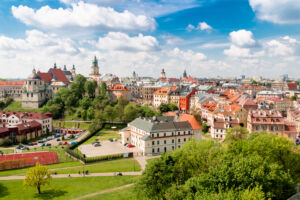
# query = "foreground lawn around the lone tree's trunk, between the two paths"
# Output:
<box><xmin>0</xmin><ymin>176</ymin><xmax>137</xmax><ymax>200</ymax></box>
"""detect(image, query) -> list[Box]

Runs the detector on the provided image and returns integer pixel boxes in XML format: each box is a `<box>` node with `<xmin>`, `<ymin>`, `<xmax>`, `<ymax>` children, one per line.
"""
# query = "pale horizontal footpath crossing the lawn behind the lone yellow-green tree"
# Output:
<box><xmin>0</xmin><ymin>172</ymin><xmax>142</xmax><ymax>181</ymax></box>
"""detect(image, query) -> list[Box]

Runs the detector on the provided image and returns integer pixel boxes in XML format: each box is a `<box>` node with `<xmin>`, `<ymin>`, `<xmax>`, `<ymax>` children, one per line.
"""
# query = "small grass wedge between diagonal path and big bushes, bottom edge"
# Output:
<box><xmin>86</xmin><ymin>186</ymin><xmax>137</xmax><ymax>200</ymax></box>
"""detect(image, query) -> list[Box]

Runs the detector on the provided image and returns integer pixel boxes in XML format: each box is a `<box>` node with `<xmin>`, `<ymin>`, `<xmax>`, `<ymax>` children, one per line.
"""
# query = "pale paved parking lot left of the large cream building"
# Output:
<box><xmin>78</xmin><ymin>141</ymin><xmax>138</xmax><ymax>157</ymax></box>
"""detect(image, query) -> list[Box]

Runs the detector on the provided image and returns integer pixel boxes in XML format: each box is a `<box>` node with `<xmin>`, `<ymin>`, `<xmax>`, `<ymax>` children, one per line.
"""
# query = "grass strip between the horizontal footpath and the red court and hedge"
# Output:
<box><xmin>0</xmin><ymin>158</ymin><xmax>141</xmax><ymax>177</ymax></box>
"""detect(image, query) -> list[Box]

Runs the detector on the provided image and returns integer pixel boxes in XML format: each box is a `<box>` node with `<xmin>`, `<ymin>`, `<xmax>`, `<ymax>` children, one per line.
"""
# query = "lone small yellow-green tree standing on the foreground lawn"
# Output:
<box><xmin>24</xmin><ymin>163</ymin><xmax>51</xmax><ymax>194</ymax></box>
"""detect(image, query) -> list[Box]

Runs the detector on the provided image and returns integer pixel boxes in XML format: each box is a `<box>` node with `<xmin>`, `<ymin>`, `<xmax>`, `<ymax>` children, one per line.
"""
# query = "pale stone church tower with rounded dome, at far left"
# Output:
<box><xmin>22</xmin><ymin>69</ymin><xmax>46</xmax><ymax>108</ymax></box>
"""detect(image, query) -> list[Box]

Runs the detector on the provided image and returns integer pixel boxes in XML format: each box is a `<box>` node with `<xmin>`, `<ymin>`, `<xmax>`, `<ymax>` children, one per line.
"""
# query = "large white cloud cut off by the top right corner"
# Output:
<box><xmin>249</xmin><ymin>0</ymin><xmax>300</xmax><ymax>24</ymax></box>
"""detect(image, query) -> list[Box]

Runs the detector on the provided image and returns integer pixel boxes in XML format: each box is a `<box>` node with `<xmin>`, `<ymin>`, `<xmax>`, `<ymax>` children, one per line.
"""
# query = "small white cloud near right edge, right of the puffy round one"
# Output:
<box><xmin>267</xmin><ymin>40</ymin><xmax>294</xmax><ymax>56</ymax></box>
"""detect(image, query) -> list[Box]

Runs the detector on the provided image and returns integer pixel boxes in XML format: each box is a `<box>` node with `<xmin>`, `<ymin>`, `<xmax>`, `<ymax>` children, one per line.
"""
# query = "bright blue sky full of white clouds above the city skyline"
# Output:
<box><xmin>0</xmin><ymin>0</ymin><xmax>300</xmax><ymax>78</ymax></box>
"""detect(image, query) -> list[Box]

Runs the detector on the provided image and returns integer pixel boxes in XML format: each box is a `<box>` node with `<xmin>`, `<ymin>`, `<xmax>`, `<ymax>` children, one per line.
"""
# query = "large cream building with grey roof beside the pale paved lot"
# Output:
<box><xmin>121</xmin><ymin>116</ymin><xmax>194</xmax><ymax>155</ymax></box>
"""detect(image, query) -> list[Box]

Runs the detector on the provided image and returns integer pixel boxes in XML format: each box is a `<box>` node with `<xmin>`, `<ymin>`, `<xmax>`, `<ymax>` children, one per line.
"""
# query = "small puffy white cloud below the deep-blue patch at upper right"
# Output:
<box><xmin>229</xmin><ymin>29</ymin><xmax>256</xmax><ymax>47</ymax></box>
